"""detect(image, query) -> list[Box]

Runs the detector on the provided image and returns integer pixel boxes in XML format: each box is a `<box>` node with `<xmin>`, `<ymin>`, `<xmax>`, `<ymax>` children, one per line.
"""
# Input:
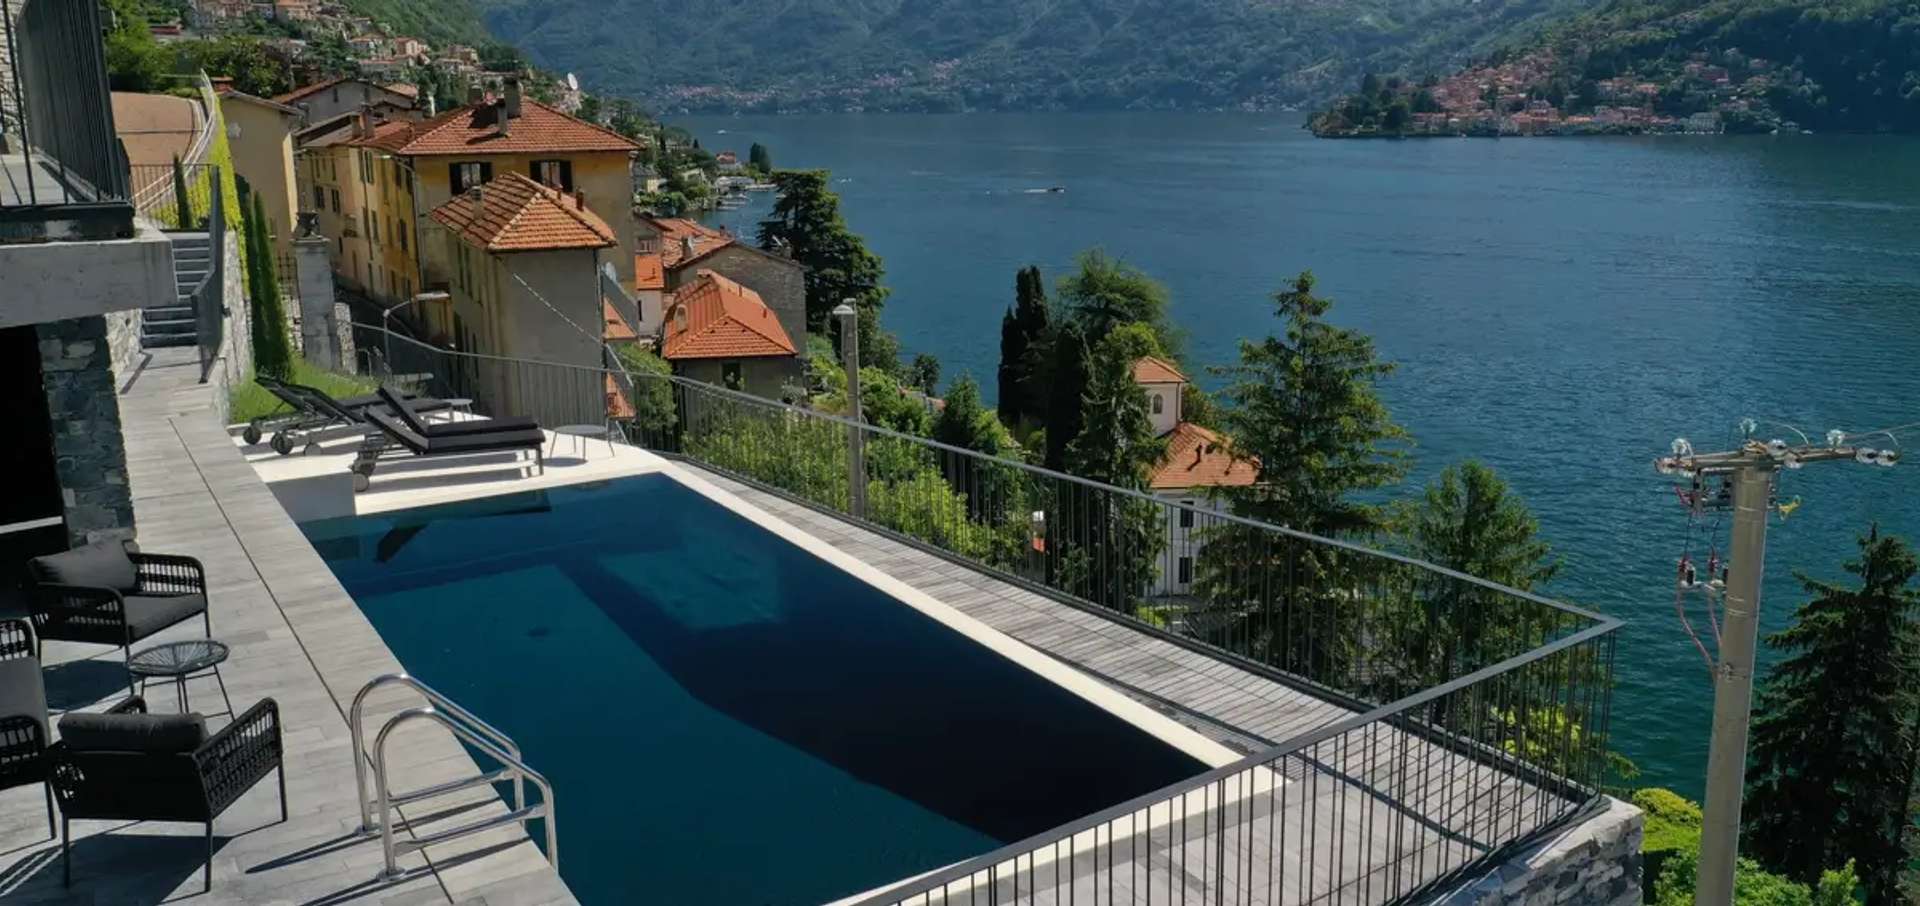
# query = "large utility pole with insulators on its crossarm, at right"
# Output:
<box><xmin>1653</xmin><ymin>433</ymin><xmax>1899</xmax><ymax>906</ymax></box>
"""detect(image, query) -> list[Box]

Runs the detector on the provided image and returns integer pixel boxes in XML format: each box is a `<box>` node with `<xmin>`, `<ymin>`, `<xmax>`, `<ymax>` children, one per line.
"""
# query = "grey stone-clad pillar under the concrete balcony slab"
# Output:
<box><xmin>35</xmin><ymin>315</ymin><xmax>134</xmax><ymax>545</ymax></box>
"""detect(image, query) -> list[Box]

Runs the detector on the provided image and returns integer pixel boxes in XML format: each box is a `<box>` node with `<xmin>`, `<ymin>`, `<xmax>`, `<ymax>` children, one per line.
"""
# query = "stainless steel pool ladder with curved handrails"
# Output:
<box><xmin>348</xmin><ymin>674</ymin><xmax>561</xmax><ymax>879</ymax></box>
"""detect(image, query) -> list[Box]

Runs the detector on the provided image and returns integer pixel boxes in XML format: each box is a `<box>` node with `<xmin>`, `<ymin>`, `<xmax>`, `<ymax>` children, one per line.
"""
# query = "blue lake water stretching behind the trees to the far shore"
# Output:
<box><xmin>678</xmin><ymin>113</ymin><xmax>1920</xmax><ymax>795</ymax></box>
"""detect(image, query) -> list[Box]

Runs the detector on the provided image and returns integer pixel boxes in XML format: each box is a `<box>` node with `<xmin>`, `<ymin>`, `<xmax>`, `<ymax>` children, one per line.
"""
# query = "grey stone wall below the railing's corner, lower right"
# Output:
<box><xmin>1430</xmin><ymin>799</ymin><xmax>1642</xmax><ymax>906</ymax></box>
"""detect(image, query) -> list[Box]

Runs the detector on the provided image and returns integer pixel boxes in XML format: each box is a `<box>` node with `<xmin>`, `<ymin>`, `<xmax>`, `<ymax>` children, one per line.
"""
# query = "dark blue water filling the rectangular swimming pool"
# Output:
<box><xmin>303</xmin><ymin>476</ymin><xmax>1204</xmax><ymax>904</ymax></box>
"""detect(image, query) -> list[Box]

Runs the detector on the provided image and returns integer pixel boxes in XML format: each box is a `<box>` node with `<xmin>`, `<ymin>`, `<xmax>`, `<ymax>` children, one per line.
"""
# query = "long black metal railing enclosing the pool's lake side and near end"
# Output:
<box><xmin>357</xmin><ymin>326</ymin><xmax>1619</xmax><ymax>906</ymax></box>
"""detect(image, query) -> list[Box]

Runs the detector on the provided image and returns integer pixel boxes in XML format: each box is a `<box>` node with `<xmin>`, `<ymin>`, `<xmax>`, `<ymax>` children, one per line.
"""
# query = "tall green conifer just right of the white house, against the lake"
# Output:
<box><xmin>1217</xmin><ymin>271</ymin><xmax>1407</xmax><ymax>537</ymax></box>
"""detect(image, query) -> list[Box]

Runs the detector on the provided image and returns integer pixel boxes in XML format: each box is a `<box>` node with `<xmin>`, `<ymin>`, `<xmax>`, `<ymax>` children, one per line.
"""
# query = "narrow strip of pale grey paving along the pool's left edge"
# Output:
<box><xmin>153</xmin><ymin>411</ymin><xmax>570</xmax><ymax>902</ymax></box>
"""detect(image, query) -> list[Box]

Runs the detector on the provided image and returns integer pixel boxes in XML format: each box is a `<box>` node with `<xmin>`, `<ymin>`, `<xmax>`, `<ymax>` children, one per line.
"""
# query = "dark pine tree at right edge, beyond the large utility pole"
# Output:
<box><xmin>1743</xmin><ymin>526</ymin><xmax>1920</xmax><ymax>906</ymax></box>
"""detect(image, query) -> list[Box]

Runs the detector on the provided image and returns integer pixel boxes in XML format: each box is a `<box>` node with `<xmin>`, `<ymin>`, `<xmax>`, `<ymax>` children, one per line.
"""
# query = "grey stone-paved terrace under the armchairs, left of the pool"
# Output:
<box><xmin>0</xmin><ymin>347</ymin><xmax>574</xmax><ymax>906</ymax></box>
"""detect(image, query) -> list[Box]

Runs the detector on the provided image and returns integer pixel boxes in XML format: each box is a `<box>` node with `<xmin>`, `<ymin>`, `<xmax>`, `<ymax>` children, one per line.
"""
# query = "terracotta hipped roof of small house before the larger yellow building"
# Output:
<box><xmin>434</xmin><ymin>173</ymin><xmax>616</xmax><ymax>251</ymax></box>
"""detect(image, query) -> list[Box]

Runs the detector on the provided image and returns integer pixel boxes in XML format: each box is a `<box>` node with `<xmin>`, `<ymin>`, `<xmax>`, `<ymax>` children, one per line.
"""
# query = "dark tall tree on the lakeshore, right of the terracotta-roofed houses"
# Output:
<box><xmin>758</xmin><ymin>171</ymin><xmax>899</xmax><ymax>372</ymax></box>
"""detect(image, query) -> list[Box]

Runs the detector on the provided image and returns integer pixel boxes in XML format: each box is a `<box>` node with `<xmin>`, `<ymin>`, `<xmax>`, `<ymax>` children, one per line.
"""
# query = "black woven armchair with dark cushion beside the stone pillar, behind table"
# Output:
<box><xmin>27</xmin><ymin>543</ymin><xmax>213</xmax><ymax>695</ymax></box>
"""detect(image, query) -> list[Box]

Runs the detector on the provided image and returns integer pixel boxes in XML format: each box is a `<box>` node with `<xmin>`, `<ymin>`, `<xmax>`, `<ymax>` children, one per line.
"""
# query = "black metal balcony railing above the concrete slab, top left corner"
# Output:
<box><xmin>0</xmin><ymin>0</ymin><xmax>132</xmax><ymax>240</ymax></box>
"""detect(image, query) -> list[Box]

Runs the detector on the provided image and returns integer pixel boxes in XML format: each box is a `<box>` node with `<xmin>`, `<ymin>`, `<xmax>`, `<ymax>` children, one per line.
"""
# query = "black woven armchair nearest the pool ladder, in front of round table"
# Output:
<box><xmin>48</xmin><ymin>697</ymin><xmax>286</xmax><ymax>891</ymax></box>
